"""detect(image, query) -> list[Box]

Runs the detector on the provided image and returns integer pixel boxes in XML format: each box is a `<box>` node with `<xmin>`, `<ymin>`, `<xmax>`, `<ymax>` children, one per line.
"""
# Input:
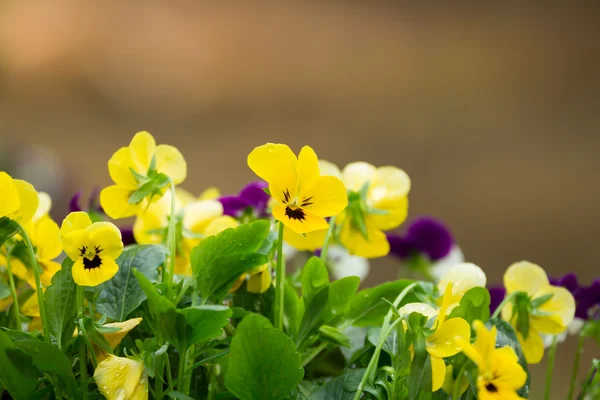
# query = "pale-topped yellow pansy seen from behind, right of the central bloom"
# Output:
<box><xmin>320</xmin><ymin>161</ymin><xmax>410</xmax><ymax>258</ymax></box>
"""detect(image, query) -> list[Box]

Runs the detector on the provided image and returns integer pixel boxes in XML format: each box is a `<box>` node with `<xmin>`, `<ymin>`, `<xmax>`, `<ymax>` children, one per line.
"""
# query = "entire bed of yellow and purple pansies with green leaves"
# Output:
<box><xmin>0</xmin><ymin>132</ymin><xmax>600</xmax><ymax>400</ymax></box>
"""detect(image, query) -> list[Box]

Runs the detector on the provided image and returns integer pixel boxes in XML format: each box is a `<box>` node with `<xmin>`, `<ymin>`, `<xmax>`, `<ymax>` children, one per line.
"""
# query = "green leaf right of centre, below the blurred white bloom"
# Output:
<box><xmin>345</xmin><ymin>280</ymin><xmax>418</xmax><ymax>326</ymax></box>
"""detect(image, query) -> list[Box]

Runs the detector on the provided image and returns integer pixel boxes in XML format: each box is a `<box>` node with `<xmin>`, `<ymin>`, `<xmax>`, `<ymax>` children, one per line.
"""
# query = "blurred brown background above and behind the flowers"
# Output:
<box><xmin>0</xmin><ymin>0</ymin><xmax>600</xmax><ymax>399</ymax></box>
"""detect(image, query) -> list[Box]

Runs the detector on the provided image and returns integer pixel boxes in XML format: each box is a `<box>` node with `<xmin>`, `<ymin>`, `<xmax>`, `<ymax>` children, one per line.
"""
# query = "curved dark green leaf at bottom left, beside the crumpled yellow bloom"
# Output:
<box><xmin>14</xmin><ymin>340</ymin><xmax>79</xmax><ymax>398</ymax></box>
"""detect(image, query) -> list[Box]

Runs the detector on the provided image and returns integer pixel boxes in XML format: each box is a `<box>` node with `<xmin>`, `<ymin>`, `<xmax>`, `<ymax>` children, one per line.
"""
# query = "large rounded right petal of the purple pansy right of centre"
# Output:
<box><xmin>406</xmin><ymin>217</ymin><xmax>454</xmax><ymax>261</ymax></box>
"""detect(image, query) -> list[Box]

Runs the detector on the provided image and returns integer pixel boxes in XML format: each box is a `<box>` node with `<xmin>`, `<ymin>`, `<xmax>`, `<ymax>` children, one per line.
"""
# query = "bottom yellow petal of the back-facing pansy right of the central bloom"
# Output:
<box><xmin>340</xmin><ymin>220</ymin><xmax>390</xmax><ymax>258</ymax></box>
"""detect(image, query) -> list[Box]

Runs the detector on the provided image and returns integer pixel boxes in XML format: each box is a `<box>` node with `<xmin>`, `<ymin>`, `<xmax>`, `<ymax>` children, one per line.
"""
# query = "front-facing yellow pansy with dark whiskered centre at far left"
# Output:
<box><xmin>60</xmin><ymin>211</ymin><xmax>123</xmax><ymax>286</ymax></box>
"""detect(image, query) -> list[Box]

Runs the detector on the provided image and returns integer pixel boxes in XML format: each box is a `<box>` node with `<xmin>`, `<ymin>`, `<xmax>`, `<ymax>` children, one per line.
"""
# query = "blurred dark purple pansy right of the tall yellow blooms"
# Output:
<box><xmin>387</xmin><ymin>217</ymin><xmax>454</xmax><ymax>261</ymax></box>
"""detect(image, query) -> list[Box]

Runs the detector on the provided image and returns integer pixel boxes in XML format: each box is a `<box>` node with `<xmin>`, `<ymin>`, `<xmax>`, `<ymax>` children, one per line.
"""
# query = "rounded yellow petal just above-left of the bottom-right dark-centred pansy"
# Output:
<box><xmin>427</xmin><ymin>318</ymin><xmax>471</xmax><ymax>360</ymax></box>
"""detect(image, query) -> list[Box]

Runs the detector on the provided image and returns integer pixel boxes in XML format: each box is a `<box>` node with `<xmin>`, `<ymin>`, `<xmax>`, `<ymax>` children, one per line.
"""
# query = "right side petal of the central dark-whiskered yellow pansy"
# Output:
<box><xmin>298</xmin><ymin>176</ymin><xmax>348</xmax><ymax>217</ymax></box>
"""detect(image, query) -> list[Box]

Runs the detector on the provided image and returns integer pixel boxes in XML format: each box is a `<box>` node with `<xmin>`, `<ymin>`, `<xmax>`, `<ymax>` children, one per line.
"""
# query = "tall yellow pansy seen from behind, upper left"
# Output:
<box><xmin>100</xmin><ymin>131</ymin><xmax>187</xmax><ymax>219</ymax></box>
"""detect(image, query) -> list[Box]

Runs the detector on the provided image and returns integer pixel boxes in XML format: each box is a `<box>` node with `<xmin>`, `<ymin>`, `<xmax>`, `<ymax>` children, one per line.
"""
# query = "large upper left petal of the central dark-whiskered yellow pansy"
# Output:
<box><xmin>248</xmin><ymin>143</ymin><xmax>298</xmax><ymax>192</ymax></box>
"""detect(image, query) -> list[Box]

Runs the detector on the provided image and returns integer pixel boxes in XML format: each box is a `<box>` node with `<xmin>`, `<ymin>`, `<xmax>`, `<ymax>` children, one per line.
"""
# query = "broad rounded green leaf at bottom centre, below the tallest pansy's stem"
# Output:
<box><xmin>225</xmin><ymin>314</ymin><xmax>304</xmax><ymax>400</ymax></box>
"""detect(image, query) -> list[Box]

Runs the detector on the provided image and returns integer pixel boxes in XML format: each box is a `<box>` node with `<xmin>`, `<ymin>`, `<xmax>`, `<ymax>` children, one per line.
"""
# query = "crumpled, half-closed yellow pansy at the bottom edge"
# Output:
<box><xmin>94</xmin><ymin>354</ymin><xmax>148</xmax><ymax>400</ymax></box>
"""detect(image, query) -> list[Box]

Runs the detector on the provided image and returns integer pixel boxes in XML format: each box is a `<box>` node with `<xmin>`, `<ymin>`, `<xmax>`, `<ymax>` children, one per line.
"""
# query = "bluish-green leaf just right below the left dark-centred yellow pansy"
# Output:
<box><xmin>96</xmin><ymin>245</ymin><xmax>166</xmax><ymax>321</ymax></box>
